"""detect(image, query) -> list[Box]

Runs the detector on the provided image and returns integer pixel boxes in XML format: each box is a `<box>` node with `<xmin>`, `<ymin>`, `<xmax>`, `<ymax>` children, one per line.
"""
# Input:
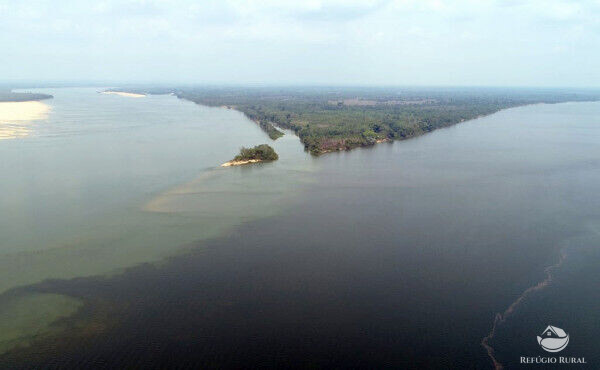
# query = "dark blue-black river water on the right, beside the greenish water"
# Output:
<box><xmin>2</xmin><ymin>97</ymin><xmax>600</xmax><ymax>368</ymax></box>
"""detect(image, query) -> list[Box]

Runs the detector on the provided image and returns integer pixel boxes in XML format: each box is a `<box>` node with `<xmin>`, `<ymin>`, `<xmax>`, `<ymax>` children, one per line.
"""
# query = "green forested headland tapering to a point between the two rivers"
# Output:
<box><xmin>115</xmin><ymin>87</ymin><xmax>600</xmax><ymax>154</ymax></box>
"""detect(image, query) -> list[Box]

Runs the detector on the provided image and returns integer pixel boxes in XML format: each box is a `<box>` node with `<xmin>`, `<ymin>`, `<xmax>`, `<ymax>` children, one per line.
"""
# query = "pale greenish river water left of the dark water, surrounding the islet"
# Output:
<box><xmin>0</xmin><ymin>88</ymin><xmax>315</xmax><ymax>352</ymax></box>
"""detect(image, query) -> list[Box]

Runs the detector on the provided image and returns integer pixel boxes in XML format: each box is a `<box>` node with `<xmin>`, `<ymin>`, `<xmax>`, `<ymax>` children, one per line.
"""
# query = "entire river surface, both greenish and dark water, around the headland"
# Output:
<box><xmin>0</xmin><ymin>89</ymin><xmax>600</xmax><ymax>368</ymax></box>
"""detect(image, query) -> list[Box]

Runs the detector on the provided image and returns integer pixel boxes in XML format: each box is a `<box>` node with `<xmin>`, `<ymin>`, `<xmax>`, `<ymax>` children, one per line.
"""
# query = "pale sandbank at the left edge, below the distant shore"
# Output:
<box><xmin>0</xmin><ymin>101</ymin><xmax>50</xmax><ymax>140</ymax></box>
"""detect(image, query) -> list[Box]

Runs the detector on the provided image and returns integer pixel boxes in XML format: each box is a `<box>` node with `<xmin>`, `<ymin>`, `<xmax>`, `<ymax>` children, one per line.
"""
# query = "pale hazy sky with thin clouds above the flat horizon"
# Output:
<box><xmin>0</xmin><ymin>0</ymin><xmax>600</xmax><ymax>87</ymax></box>
